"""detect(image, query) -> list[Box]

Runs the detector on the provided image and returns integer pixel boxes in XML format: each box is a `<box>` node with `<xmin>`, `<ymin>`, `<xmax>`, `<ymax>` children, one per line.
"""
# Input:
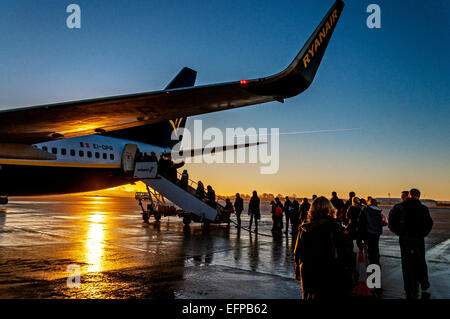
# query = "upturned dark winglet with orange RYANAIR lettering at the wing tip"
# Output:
<box><xmin>246</xmin><ymin>0</ymin><xmax>344</xmax><ymax>101</ymax></box>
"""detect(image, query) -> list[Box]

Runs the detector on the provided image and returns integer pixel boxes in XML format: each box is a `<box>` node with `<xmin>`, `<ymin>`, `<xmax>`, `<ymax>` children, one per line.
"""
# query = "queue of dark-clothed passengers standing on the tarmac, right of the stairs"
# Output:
<box><xmin>221</xmin><ymin>188</ymin><xmax>433</xmax><ymax>299</ymax></box>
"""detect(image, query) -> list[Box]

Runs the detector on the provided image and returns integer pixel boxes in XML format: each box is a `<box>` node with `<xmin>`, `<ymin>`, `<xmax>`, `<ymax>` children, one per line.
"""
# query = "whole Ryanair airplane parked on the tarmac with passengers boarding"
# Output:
<box><xmin>0</xmin><ymin>0</ymin><xmax>344</xmax><ymax>204</ymax></box>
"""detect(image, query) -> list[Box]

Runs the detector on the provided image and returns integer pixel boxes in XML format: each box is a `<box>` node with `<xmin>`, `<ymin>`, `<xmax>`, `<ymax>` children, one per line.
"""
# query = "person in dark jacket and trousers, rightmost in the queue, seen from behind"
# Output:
<box><xmin>389</xmin><ymin>188</ymin><xmax>433</xmax><ymax>299</ymax></box>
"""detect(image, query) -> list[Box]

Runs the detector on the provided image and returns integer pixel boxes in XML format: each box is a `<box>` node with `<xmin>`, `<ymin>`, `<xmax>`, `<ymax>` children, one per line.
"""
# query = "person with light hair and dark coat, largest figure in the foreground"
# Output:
<box><xmin>294</xmin><ymin>196</ymin><xmax>353</xmax><ymax>299</ymax></box>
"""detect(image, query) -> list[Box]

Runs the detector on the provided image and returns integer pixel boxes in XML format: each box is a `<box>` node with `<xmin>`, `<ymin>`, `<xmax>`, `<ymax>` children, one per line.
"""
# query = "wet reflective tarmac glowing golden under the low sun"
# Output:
<box><xmin>0</xmin><ymin>196</ymin><xmax>450</xmax><ymax>299</ymax></box>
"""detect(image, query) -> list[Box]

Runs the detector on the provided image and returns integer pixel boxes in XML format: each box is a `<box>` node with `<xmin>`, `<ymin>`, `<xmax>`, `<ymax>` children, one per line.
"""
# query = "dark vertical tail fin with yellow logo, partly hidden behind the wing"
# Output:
<box><xmin>106</xmin><ymin>67</ymin><xmax>197</xmax><ymax>149</ymax></box>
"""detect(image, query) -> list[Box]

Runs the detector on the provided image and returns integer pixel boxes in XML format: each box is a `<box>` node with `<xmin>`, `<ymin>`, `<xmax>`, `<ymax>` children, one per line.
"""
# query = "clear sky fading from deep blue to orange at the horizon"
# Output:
<box><xmin>0</xmin><ymin>0</ymin><xmax>450</xmax><ymax>199</ymax></box>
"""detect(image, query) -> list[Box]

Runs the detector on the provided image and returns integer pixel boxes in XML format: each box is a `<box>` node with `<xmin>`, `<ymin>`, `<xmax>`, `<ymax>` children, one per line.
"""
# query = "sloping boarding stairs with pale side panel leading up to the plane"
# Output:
<box><xmin>135</xmin><ymin>163</ymin><xmax>230</xmax><ymax>223</ymax></box>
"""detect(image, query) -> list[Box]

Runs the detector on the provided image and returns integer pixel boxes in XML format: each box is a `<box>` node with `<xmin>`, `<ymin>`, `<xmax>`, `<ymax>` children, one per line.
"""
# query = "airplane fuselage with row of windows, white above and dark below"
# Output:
<box><xmin>0</xmin><ymin>135</ymin><xmax>170</xmax><ymax>196</ymax></box>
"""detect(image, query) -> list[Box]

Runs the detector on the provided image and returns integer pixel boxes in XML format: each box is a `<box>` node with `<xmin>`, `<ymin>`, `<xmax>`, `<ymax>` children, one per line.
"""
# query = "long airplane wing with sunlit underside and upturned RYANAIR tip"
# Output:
<box><xmin>0</xmin><ymin>0</ymin><xmax>344</xmax><ymax>144</ymax></box>
